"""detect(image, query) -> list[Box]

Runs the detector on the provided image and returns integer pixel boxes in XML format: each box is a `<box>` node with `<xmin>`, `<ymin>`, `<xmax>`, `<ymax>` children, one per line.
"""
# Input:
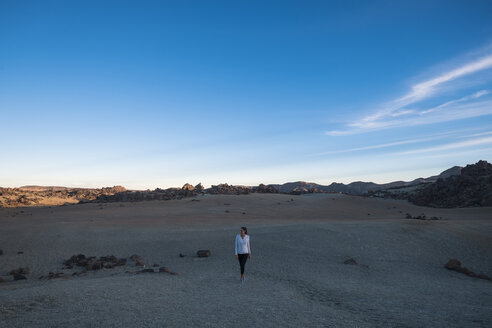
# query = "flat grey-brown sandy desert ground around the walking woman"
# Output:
<box><xmin>0</xmin><ymin>194</ymin><xmax>492</xmax><ymax>327</ymax></box>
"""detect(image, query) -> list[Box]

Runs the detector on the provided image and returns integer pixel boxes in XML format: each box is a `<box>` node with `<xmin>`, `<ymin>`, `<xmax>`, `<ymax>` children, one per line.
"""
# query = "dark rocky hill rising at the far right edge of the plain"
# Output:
<box><xmin>409</xmin><ymin>161</ymin><xmax>492</xmax><ymax>207</ymax></box>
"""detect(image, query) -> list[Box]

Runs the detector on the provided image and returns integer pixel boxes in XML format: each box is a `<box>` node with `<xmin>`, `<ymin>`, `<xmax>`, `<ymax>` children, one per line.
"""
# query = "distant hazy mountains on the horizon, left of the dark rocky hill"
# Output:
<box><xmin>269</xmin><ymin>166</ymin><xmax>463</xmax><ymax>195</ymax></box>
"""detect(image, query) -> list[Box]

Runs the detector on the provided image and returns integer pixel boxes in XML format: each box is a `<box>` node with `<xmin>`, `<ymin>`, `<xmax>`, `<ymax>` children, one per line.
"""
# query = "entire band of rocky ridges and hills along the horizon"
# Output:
<box><xmin>0</xmin><ymin>161</ymin><xmax>492</xmax><ymax>207</ymax></box>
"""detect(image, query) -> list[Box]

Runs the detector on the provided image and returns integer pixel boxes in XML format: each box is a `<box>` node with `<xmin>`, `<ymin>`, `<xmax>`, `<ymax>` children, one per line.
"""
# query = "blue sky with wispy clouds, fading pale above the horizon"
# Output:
<box><xmin>0</xmin><ymin>0</ymin><xmax>492</xmax><ymax>189</ymax></box>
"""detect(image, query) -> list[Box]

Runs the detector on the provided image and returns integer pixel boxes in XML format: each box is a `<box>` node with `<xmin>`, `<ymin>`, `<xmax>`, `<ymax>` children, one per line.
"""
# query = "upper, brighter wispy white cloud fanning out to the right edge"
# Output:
<box><xmin>326</xmin><ymin>54</ymin><xmax>492</xmax><ymax>136</ymax></box>
